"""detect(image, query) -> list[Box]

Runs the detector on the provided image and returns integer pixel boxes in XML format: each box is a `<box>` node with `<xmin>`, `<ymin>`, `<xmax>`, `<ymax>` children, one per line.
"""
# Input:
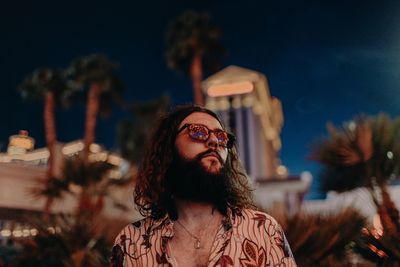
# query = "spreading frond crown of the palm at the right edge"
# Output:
<box><xmin>310</xmin><ymin>114</ymin><xmax>400</xmax><ymax>191</ymax></box>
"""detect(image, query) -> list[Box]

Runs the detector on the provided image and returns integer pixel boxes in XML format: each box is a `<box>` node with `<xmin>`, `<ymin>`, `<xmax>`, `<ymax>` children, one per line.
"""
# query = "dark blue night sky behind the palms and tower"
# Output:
<box><xmin>0</xmin><ymin>0</ymin><xmax>400</xmax><ymax>198</ymax></box>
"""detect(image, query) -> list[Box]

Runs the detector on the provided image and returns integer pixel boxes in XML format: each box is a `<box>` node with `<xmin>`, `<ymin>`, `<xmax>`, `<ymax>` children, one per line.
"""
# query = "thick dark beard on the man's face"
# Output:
<box><xmin>165</xmin><ymin>151</ymin><xmax>229</xmax><ymax>207</ymax></box>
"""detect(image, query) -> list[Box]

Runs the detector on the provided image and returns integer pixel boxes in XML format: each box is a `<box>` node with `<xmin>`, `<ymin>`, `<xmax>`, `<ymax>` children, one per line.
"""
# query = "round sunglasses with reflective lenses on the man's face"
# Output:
<box><xmin>176</xmin><ymin>123</ymin><xmax>236</xmax><ymax>149</ymax></box>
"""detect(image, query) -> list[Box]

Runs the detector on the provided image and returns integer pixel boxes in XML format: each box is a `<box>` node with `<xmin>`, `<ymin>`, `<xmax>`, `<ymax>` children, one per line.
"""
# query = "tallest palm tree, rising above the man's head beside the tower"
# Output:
<box><xmin>166</xmin><ymin>11</ymin><xmax>224</xmax><ymax>105</ymax></box>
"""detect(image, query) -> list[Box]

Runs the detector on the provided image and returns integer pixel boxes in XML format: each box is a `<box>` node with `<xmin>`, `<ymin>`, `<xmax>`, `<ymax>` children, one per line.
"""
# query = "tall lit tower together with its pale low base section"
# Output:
<box><xmin>202</xmin><ymin>66</ymin><xmax>312</xmax><ymax>214</ymax></box>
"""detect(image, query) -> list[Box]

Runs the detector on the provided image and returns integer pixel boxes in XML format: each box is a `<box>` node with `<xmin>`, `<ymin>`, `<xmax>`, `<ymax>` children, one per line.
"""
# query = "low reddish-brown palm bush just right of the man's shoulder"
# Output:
<box><xmin>273</xmin><ymin>208</ymin><xmax>366</xmax><ymax>267</ymax></box>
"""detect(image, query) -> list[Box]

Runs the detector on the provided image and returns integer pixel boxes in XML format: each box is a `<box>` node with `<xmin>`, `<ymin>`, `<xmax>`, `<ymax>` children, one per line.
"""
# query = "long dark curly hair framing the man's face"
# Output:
<box><xmin>134</xmin><ymin>105</ymin><xmax>254</xmax><ymax>219</ymax></box>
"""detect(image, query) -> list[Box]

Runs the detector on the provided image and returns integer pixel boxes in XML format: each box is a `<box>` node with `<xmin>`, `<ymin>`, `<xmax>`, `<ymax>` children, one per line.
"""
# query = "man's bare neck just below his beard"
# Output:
<box><xmin>175</xmin><ymin>198</ymin><xmax>222</xmax><ymax>224</ymax></box>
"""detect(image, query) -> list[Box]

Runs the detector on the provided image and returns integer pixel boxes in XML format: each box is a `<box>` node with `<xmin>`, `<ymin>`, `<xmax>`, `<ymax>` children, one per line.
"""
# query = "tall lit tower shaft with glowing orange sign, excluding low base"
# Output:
<box><xmin>203</xmin><ymin>66</ymin><xmax>288</xmax><ymax>181</ymax></box>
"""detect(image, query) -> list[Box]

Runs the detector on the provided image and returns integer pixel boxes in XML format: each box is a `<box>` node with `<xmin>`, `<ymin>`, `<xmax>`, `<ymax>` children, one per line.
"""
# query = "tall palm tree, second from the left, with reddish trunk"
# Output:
<box><xmin>67</xmin><ymin>54</ymin><xmax>123</xmax><ymax>162</ymax></box>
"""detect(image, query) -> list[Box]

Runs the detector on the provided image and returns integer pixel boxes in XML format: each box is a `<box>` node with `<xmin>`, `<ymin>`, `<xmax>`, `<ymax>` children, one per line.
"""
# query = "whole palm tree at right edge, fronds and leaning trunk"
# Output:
<box><xmin>311</xmin><ymin>114</ymin><xmax>400</xmax><ymax>261</ymax></box>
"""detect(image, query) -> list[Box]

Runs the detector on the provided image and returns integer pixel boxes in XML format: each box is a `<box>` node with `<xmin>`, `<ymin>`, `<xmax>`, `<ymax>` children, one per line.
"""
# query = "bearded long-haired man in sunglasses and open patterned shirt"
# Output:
<box><xmin>111</xmin><ymin>106</ymin><xmax>296</xmax><ymax>267</ymax></box>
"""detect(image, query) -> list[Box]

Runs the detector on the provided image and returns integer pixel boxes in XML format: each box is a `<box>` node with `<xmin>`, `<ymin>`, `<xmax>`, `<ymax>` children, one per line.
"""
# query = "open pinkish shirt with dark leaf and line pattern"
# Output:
<box><xmin>110</xmin><ymin>209</ymin><xmax>296</xmax><ymax>267</ymax></box>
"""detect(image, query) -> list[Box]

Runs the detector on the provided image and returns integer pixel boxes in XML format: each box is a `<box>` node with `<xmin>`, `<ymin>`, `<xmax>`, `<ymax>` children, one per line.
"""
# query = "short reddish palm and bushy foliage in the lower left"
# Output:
<box><xmin>16</xmin><ymin>156</ymin><xmax>132</xmax><ymax>267</ymax></box>
